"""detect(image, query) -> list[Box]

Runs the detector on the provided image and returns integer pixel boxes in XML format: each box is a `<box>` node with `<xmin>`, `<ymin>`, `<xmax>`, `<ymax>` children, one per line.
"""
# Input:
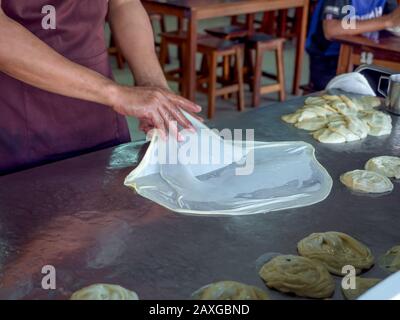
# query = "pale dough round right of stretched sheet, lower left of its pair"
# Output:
<box><xmin>340</xmin><ymin>170</ymin><xmax>393</xmax><ymax>193</ymax></box>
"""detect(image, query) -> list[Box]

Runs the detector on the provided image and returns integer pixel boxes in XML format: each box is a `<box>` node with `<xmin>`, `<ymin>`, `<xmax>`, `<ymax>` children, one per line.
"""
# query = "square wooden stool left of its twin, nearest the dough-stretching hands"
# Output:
<box><xmin>197</xmin><ymin>37</ymin><xmax>244</xmax><ymax>118</ymax></box>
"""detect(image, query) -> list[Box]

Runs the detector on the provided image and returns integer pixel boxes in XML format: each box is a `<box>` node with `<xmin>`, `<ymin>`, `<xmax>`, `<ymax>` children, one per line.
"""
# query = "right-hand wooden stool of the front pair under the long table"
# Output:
<box><xmin>246</xmin><ymin>33</ymin><xmax>286</xmax><ymax>107</ymax></box>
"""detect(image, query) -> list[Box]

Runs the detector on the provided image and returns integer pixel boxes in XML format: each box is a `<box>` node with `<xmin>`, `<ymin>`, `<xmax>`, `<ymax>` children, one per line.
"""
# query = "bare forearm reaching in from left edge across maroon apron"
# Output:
<box><xmin>0</xmin><ymin>9</ymin><xmax>119</xmax><ymax>105</ymax></box>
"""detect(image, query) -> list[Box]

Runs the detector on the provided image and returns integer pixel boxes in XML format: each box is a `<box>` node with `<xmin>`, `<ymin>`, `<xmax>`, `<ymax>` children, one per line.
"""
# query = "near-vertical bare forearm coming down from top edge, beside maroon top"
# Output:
<box><xmin>109</xmin><ymin>0</ymin><xmax>168</xmax><ymax>88</ymax></box>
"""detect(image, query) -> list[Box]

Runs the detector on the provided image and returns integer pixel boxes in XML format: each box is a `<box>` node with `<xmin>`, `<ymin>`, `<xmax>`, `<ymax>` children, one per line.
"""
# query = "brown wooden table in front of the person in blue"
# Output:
<box><xmin>335</xmin><ymin>32</ymin><xmax>400</xmax><ymax>74</ymax></box>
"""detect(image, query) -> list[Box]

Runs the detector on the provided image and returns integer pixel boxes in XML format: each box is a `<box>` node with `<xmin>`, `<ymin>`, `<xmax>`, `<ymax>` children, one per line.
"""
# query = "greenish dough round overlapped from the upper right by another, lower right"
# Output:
<box><xmin>259</xmin><ymin>255</ymin><xmax>335</xmax><ymax>299</ymax></box>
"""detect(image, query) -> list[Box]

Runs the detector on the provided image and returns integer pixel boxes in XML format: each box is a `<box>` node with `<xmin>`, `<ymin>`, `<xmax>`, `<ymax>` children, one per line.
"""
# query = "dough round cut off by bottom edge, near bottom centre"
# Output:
<box><xmin>192</xmin><ymin>281</ymin><xmax>269</xmax><ymax>300</ymax></box>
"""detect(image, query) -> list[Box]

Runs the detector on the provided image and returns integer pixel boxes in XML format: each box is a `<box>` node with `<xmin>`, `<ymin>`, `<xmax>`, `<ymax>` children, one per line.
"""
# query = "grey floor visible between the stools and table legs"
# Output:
<box><xmin>111</xmin><ymin>17</ymin><xmax>309</xmax><ymax>140</ymax></box>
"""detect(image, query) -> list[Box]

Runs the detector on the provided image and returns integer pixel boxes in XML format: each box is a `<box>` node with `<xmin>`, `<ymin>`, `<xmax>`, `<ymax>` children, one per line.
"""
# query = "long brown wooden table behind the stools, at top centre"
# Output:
<box><xmin>142</xmin><ymin>0</ymin><xmax>309</xmax><ymax>101</ymax></box>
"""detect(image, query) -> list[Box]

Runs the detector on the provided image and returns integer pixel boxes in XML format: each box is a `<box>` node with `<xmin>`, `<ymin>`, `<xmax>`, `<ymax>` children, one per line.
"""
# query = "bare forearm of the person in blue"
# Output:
<box><xmin>323</xmin><ymin>16</ymin><xmax>390</xmax><ymax>40</ymax></box>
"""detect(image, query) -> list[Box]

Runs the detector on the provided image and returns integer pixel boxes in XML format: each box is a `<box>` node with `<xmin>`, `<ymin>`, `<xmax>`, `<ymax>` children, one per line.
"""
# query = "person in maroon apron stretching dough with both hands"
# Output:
<box><xmin>0</xmin><ymin>0</ymin><xmax>200</xmax><ymax>174</ymax></box>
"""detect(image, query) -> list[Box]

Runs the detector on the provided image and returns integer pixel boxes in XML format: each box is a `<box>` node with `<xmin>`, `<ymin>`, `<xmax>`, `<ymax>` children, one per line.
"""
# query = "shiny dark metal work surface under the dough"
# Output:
<box><xmin>0</xmin><ymin>94</ymin><xmax>400</xmax><ymax>299</ymax></box>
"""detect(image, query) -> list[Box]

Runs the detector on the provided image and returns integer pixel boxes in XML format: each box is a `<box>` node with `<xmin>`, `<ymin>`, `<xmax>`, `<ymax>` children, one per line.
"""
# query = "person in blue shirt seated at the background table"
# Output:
<box><xmin>307</xmin><ymin>0</ymin><xmax>400</xmax><ymax>91</ymax></box>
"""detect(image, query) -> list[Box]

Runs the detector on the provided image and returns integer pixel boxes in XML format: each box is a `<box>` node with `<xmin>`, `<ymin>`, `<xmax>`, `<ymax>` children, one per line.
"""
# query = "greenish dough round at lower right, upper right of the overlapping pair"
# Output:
<box><xmin>297</xmin><ymin>232</ymin><xmax>374</xmax><ymax>275</ymax></box>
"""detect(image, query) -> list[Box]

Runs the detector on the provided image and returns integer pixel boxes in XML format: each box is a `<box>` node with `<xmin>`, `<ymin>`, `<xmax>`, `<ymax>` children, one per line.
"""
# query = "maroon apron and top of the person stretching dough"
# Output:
<box><xmin>0</xmin><ymin>0</ymin><xmax>130</xmax><ymax>174</ymax></box>
